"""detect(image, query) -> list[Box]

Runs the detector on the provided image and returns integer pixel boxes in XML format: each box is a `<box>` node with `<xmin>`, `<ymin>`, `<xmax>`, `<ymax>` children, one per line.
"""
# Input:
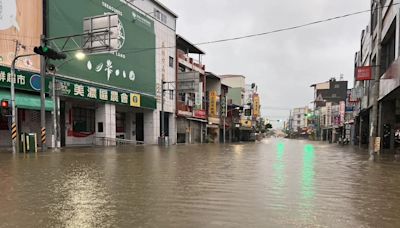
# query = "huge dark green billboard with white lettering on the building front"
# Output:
<box><xmin>47</xmin><ymin>0</ymin><xmax>156</xmax><ymax>96</ymax></box>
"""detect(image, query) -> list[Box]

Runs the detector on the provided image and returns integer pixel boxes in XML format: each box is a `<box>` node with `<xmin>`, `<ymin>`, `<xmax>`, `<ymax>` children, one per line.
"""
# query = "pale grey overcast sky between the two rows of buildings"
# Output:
<box><xmin>162</xmin><ymin>0</ymin><xmax>370</xmax><ymax>126</ymax></box>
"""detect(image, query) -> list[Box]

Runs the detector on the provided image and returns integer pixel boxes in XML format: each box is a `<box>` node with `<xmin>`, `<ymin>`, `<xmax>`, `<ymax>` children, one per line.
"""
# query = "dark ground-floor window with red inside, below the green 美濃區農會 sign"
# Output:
<box><xmin>72</xmin><ymin>108</ymin><xmax>95</xmax><ymax>132</ymax></box>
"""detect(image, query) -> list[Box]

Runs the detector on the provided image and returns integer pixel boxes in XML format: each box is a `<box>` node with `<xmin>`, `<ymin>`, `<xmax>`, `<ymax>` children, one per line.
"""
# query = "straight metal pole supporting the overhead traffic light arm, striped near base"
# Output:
<box><xmin>40</xmin><ymin>35</ymin><xmax>47</xmax><ymax>152</ymax></box>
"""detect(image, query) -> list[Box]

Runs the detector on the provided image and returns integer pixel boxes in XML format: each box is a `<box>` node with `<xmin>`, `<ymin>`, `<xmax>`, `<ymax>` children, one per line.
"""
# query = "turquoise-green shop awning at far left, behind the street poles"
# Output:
<box><xmin>0</xmin><ymin>90</ymin><xmax>54</xmax><ymax>111</ymax></box>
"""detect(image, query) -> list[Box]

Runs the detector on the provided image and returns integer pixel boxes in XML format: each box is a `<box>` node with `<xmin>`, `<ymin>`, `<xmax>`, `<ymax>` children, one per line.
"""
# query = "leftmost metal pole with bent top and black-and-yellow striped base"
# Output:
<box><xmin>10</xmin><ymin>40</ymin><xmax>19</xmax><ymax>154</ymax></box>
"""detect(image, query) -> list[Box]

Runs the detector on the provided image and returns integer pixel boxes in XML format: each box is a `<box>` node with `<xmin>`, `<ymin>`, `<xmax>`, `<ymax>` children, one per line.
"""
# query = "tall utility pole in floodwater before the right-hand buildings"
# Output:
<box><xmin>369</xmin><ymin>1</ymin><xmax>382</xmax><ymax>158</ymax></box>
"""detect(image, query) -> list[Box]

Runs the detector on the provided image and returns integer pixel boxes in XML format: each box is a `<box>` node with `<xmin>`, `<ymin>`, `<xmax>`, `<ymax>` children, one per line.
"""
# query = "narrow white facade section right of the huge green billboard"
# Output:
<box><xmin>133</xmin><ymin>0</ymin><xmax>178</xmax><ymax>144</ymax></box>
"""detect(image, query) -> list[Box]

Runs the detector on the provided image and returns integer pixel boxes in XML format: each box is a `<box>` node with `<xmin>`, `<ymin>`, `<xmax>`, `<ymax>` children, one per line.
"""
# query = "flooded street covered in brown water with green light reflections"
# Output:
<box><xmin>0</xmin><ymin>139</ymin><xmax>400</xmax><ymax>227</ymax></box>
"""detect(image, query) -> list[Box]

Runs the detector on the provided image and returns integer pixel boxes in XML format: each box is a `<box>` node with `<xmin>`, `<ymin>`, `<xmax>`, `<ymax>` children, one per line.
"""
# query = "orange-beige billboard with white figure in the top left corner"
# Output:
<box><xmin>0</xmin><ymin>0</ymin><xmax>43</xmax><ymax>72</ymax></box>
